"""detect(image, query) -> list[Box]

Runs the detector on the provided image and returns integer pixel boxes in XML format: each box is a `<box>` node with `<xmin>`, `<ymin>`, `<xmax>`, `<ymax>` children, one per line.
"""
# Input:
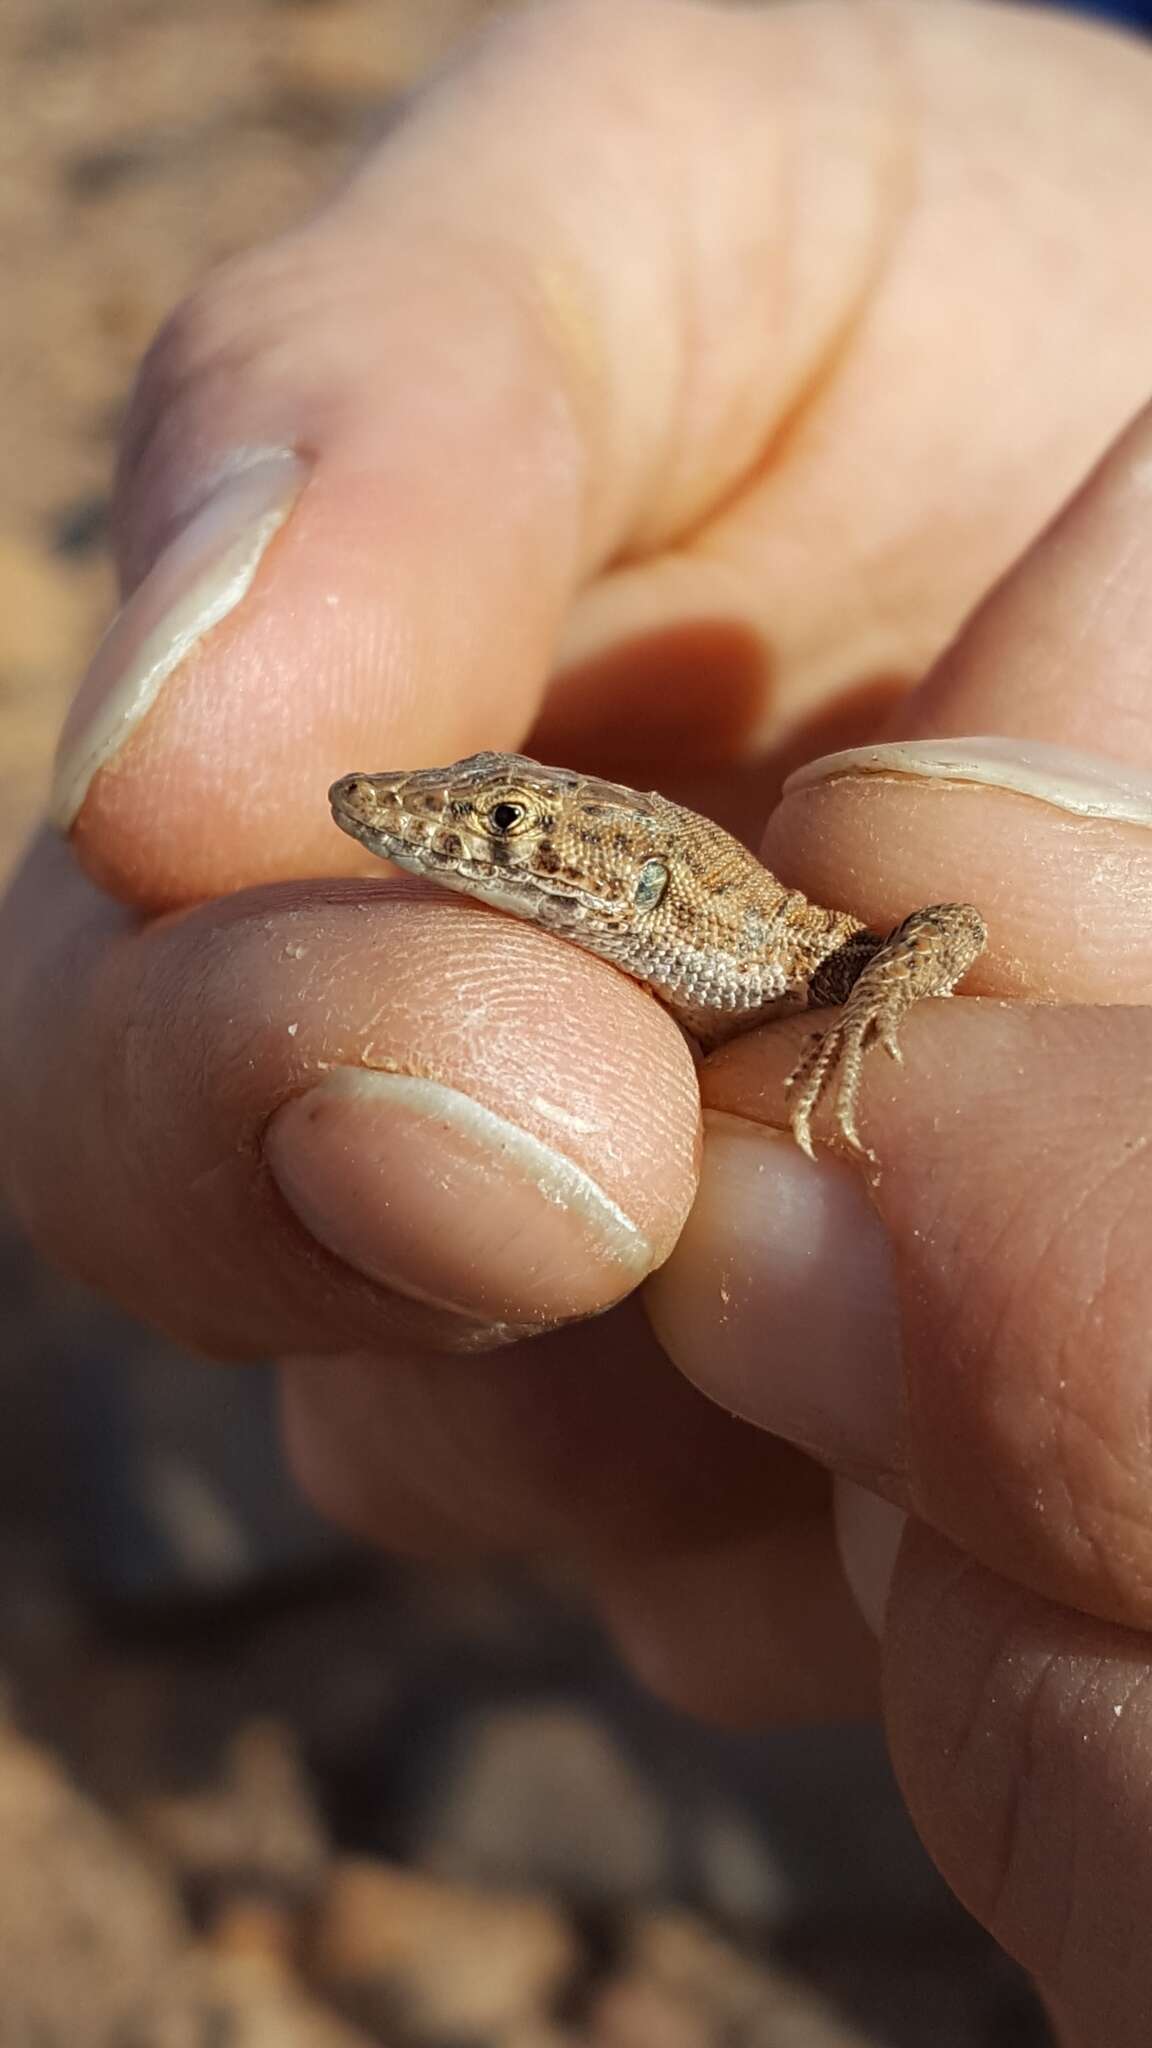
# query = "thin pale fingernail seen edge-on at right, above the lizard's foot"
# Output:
<box><xmin>783</xmin><ymin>733</ymin><xmax>1152</xmax><ymax>825</ymax></box>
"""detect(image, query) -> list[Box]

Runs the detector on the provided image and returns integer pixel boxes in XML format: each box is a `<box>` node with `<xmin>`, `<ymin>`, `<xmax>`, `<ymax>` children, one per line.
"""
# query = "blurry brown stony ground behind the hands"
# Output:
<box><xmin>0</xmin><ymin>0</ymin><xmax>1144</xmax><ymax>2048</ymax></box>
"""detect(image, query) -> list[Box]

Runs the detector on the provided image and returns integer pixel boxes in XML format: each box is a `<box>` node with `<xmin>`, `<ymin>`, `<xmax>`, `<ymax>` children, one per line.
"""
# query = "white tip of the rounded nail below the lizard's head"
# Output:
<box><xmin>316</xmin><ymin>1067</ymin><xmax>652</xmax><ymax>1274</ymax></box>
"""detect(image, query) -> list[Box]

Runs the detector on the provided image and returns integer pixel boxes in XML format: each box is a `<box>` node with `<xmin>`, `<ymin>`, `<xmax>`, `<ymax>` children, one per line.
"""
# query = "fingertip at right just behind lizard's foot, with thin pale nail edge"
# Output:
<box><xmin>763</xmin><ymin>733</ymin><xmax>1152</xmax><ymax>1004</ymax></box>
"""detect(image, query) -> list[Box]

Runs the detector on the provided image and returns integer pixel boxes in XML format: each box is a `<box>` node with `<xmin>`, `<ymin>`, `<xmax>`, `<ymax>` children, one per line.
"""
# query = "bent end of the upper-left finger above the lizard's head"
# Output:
<box><xmin>53</xmin><ymin>199</ymin><xmax>582</xmax><ymax>909</ymax></box>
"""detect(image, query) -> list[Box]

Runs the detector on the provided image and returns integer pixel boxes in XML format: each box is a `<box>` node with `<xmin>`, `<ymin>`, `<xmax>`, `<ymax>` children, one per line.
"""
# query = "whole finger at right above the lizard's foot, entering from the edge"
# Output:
<box><xmin>765</xmin><ymin>408</ymin><xmax>1152</xmax><ymax>1001</ymax></box>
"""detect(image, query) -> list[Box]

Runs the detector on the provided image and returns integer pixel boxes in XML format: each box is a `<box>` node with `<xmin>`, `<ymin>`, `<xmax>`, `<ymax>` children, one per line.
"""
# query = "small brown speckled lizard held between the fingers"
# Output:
<box><xmin>328</xmin><ymin>754</ymin><xmax>988</xmax><ymax>1157</ymax></box>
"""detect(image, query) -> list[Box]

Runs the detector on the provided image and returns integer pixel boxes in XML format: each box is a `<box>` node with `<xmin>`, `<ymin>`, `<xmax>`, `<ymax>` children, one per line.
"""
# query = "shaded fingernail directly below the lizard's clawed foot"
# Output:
<box><xmin>644</xmin><ymin>1110</ymin><xmax>906</xmax><ymax>1477</ymax></box>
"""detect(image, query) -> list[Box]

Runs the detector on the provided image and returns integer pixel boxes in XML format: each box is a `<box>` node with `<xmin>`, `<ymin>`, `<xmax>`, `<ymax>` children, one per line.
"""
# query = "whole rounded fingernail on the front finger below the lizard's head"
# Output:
<box><xmin>264</xmin><ymin>1067</ymin><xmax>652</xmax><ymax>1323</ymax></box>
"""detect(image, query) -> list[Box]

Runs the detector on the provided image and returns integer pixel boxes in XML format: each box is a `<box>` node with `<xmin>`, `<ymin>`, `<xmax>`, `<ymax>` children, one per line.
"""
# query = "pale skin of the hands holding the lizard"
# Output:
<box><xmin>11</xmin><ymin>0</ymin><xmax>1152</xmax><ymax>2048</ymax></box>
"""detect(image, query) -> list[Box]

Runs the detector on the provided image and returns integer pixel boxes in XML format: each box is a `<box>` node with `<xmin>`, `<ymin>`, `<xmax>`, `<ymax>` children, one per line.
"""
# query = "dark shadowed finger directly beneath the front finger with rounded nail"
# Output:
<box><xmin>283</xmin><ymin>1305</ymin><xmax>815</xmax><ymax>1569</ymax></box>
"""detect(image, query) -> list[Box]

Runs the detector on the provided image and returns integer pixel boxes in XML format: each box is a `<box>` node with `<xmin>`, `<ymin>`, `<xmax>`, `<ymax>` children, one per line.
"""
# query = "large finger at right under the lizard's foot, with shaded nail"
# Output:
<box><xmin>648</xmin><ymin>1004</ymin><xmax>1152</xmax><ymax>1626</ymax></box>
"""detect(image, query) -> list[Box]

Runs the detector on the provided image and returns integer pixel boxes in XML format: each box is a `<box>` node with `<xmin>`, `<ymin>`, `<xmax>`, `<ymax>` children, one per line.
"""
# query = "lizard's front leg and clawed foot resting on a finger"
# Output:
<box><xmin>785</xmin><ymin>903</ymin><xmax>988</xmax><ymax>1159</ymax></box>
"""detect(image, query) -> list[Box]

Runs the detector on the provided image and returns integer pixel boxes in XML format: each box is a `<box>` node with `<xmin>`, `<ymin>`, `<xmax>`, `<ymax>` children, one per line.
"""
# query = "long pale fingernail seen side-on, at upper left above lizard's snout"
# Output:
<box><xmin>49</xmin><ymin>449</ymin><xmax>307</xmax><ymax>831</ymax></box>
